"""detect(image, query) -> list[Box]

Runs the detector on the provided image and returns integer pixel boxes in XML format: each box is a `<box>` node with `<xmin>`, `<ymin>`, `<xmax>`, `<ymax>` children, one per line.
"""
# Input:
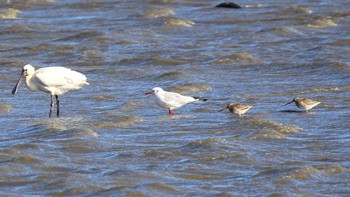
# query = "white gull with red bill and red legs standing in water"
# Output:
<box><xmin>146</xmin><ymin>87</ymin><xmax>207</xmax><ymax>116</ymax></box>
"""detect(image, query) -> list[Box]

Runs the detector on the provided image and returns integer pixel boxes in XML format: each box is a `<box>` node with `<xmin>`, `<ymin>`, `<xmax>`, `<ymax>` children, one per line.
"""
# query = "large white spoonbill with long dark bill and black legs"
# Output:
<box><xmin>12</xmin><ymin>64</ymin><xmax>89</xmax><ymax>117</ymax></box>
